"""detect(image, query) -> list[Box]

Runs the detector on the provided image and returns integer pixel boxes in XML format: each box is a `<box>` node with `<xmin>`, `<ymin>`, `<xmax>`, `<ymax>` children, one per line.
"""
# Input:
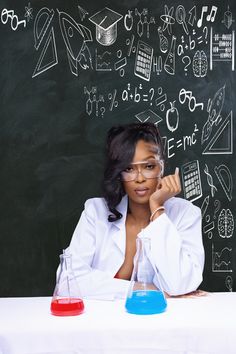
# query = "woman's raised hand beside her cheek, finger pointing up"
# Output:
<box><xmin>149</xmin><ymin>167</ymin><xmax>181</xmax><ymax>212</ymax></box>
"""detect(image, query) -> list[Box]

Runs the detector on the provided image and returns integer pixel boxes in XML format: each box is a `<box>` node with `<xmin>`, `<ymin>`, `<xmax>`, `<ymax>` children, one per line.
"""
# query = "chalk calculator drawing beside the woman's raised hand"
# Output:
<box><xmin>181</xmin><ymin>160</ymin><xmax>202</xmax><ymax>202</ymax></box>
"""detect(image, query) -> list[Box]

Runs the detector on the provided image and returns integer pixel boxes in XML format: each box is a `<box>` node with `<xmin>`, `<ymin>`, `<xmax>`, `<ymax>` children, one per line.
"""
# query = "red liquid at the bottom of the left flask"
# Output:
<box><xmin>51</xmin><ymin>298</ymin><xmax>84</xmax><ymax>316</ymax></box>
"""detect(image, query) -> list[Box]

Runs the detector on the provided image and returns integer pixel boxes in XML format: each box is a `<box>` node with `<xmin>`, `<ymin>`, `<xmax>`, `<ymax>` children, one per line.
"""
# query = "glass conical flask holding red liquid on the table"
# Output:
<box><xmin>51</xmin><ymin>251</ymin><xmax>84</xmax><ymax>316</ymax></box>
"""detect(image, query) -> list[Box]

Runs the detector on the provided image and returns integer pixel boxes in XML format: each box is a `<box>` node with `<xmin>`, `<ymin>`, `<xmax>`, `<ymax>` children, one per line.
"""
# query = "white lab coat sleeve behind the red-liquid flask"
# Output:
<box><xmin>66</xmin><ymin>204</ymin><xmax>130</xmax><ymax>300</ymax></box>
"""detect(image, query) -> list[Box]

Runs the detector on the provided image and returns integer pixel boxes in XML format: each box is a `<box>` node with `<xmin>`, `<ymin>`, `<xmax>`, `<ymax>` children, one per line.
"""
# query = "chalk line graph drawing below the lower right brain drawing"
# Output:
<box><xmin>212</xmin><ymin>243</ymin><xmax>232</xmax><ymax>273</ymax></box>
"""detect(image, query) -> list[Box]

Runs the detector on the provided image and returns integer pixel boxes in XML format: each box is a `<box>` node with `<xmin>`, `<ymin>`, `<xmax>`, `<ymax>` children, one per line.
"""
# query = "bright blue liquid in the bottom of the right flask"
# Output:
<box><xmin>125</xmin><ymin>290</ymin><xmax>167</xmax><ymax>315</ymax></box>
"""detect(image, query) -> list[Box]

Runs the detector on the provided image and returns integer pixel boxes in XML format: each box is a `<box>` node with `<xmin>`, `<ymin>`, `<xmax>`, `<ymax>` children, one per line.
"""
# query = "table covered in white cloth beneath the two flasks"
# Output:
<box><xmin>0</xmin><ymin>293</ymin><xmax>236</xmax><ymax>354</ymax></box>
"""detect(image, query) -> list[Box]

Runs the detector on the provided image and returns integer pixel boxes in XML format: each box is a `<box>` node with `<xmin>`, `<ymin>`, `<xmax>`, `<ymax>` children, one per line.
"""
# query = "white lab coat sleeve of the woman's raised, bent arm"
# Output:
<box><xmin>140</xmin><ymin>203</ymin><xmax>204</xmax><ymax>295</ymax></box>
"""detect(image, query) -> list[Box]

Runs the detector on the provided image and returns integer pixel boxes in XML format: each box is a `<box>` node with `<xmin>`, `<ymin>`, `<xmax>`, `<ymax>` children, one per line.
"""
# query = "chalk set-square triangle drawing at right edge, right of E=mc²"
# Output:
<box><xmin>202</xmin><ymin>111</ymin><xmax>233</xmax><ymax>155</ymax></box>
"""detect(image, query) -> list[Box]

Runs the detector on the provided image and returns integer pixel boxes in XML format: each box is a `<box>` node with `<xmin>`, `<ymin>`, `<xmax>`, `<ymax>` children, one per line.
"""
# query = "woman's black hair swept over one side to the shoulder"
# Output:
<box><xmin>102</xmin><ymin>122</ymin><xmax>164</xmax><ymax>222</ymax></box>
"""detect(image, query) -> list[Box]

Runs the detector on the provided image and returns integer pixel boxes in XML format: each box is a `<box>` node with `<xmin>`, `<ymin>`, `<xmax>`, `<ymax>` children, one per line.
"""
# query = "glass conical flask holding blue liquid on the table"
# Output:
<box><xmin>125</xmin><ymin>237</ymin><xmax>167</xmax><ymax>315</ymax></box>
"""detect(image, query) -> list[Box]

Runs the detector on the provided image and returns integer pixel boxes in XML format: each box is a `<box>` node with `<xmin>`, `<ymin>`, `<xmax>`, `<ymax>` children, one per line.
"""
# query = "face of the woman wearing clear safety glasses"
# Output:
<box><xmin>123</xmin><ymin>140</ymin><xmax>160</xmax><ymax>204</ymax></box>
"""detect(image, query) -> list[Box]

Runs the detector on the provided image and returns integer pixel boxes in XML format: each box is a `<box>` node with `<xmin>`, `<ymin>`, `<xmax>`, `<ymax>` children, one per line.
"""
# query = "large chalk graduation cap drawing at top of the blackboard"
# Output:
<box><xmin>89</xmin><ymin>7</ymin><xmax>123</xmax><ymax>46</ymax></box>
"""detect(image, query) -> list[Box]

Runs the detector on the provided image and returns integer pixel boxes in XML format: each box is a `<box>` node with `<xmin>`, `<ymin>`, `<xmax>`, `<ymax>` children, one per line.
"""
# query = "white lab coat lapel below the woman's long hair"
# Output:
<box><xmin>111</xmin><ymin>196</ymin><xmax>128</xmax><ymax>255</ymax></box>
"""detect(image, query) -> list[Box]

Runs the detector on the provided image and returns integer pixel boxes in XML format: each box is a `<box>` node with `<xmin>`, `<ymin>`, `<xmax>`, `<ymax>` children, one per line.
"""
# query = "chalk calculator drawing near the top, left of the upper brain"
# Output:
<box><xmin>134</xmin><ymin>41</ymin><xmax>153</xmax><ymax>81</ymax></box>
